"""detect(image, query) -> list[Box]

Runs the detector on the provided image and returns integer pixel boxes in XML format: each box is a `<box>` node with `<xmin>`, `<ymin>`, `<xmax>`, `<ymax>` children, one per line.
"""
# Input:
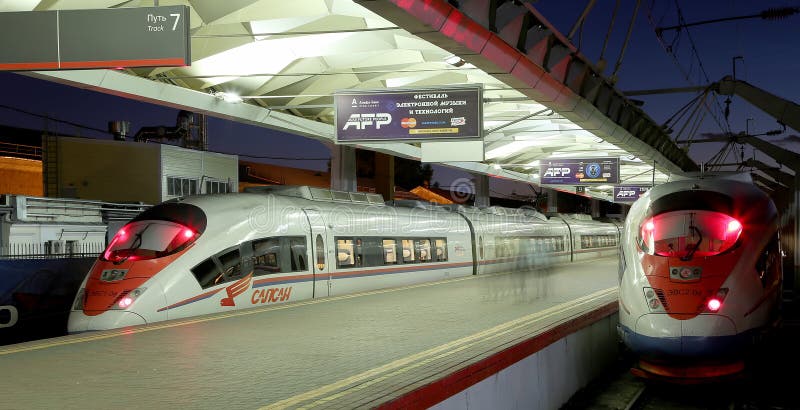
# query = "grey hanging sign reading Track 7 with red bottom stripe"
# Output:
<box><xmin>0</xmin><ymin>6</ymin><xmax>191</xmax><ymax>71</ymax></box>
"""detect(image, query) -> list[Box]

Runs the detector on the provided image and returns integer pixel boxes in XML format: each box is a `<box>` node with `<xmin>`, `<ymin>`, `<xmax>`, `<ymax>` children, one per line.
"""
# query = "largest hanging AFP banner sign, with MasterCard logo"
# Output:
<box><xmin>334</xmin><ymin>87</ymin><xmax>483</xmax><ymax>144</ymax></box>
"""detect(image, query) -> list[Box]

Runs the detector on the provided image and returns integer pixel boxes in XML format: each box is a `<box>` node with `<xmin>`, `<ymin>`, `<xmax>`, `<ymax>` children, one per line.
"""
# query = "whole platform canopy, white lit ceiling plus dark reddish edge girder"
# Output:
<box><xmin>0</xmin><ymin>0</ymin><xmax>696</xmax><ymax>199</ymax></box>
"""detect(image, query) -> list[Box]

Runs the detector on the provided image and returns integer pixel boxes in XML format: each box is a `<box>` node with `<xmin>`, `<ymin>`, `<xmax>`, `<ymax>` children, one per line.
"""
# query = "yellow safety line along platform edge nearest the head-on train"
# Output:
<box><xmin>261</xmin><ymin>286</ymin><xmax>618</xmax><ymax>410</ymax></box>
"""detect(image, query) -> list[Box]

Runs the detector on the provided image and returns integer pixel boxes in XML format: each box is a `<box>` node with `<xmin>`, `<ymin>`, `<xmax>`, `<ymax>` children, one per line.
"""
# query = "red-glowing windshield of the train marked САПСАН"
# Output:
<box><xmin>101</xmin><ymin>203</ymin><xmax>206</xmax><ymax>263</ymax></box>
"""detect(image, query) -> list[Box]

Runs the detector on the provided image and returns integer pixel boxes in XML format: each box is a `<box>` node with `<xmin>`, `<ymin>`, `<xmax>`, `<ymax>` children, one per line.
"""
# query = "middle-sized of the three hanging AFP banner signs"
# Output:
<box><xmin>539</xmin><ymin>158</ymin><xmax>619</xmax><ymax>185</ymax></box>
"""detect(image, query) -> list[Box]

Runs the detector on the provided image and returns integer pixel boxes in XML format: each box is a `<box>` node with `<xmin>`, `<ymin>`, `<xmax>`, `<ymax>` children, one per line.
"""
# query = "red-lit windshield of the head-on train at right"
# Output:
<box><xmin>638</xmin><ymin>210</ymin><xmax>742</xmax><ymax>261</ymax></box>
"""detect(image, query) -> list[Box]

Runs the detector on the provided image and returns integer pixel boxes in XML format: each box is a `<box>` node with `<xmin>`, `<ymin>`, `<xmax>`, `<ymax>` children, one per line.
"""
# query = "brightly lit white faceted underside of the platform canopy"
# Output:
<box><xmin>0</xmin><ymin>0</ymin><xmax>694</xmax><ymax>199</ymax></box>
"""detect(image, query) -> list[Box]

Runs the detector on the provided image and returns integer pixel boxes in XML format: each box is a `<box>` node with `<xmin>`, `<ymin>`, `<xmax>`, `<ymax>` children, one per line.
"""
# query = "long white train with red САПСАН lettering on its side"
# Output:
<box><xmin>68</xmin><ymin>187</ymin><xmax>619</xmax><ymax>333</ymax></box>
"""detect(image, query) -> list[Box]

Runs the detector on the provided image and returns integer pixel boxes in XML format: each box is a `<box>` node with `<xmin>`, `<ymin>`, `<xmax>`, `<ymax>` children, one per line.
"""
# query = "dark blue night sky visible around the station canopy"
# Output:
<box><xmin>0</xmin><ymin>0</ymin><xmax>800</xmax><ymax>194</ymax></box>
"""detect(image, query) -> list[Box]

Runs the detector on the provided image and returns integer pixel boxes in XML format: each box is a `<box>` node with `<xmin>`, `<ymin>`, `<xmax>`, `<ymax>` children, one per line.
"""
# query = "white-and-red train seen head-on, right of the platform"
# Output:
<box><xmin>619</xmin><ymin>174</ymin><xmax>782</xmax><ymax>379</ymax></box>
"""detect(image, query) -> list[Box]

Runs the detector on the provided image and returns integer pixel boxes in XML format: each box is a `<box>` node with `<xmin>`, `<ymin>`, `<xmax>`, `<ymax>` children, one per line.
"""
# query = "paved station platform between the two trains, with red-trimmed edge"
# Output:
<box><xmin>0</xmin><ymin>257</ymin><xmax>617</xmax><ymax>409</ymax></box>
